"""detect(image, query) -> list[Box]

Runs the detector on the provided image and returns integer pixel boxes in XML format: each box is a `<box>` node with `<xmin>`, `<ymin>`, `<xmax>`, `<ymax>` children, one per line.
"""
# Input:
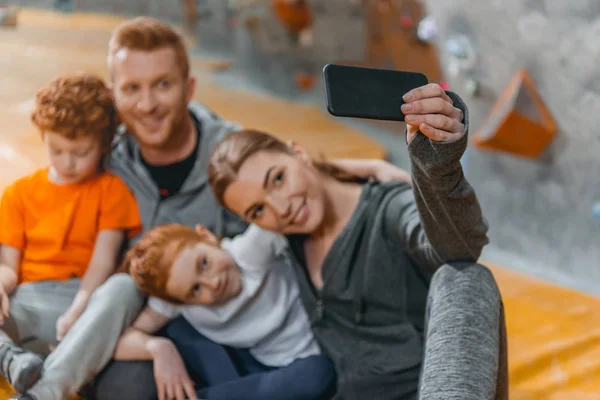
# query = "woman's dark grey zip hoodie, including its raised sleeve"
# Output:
<box><xmin>286</xmin><ymin>94</ymin><xmax>488</xmax><ymax>400</ymax></box>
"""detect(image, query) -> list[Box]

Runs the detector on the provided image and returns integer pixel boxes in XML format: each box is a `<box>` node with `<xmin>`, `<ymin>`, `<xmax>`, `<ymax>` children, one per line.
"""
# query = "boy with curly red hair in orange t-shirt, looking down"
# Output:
<box><xmin>0</xmin><ymin>75</ymin><xmax>141</xmax><ymax>392</ymax></box>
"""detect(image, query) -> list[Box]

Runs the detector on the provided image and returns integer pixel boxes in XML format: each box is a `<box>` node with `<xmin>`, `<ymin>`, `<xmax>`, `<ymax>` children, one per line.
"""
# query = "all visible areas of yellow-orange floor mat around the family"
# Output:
<box><xmin>0</xmin><ymin>6</ymin><xmax>600</xmax><ymax>400</ymax></box>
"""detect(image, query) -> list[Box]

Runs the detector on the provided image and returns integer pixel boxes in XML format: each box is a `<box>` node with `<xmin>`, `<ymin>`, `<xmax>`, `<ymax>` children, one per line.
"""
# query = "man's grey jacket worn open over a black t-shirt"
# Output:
<box><xmin>107</xmin><ymin>103</ymin><xmax>247</xmax><ymax>241</ymax></box>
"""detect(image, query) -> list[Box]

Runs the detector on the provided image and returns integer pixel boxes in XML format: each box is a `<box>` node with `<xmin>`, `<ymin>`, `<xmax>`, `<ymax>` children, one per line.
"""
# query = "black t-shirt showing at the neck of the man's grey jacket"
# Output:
<box><xmin>140</xmin><ymin>115</ymin><xmax>202</xmax><ymax>199</ymax></box>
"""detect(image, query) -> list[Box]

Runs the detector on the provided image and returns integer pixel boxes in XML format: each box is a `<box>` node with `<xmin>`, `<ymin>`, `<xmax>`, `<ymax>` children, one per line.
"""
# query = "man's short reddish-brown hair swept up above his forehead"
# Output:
<box><xmin>108</xmin><ymin>17</ymin><xmax>190</xmax><ymax>78</ymax></box>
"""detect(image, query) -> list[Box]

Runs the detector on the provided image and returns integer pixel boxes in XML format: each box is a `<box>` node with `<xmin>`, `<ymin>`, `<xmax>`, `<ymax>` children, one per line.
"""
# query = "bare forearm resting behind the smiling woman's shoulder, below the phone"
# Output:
<box><xmin>327</xmin><ymin>158</ymin><xmax>411</xmax><ymax>183</ymax></box>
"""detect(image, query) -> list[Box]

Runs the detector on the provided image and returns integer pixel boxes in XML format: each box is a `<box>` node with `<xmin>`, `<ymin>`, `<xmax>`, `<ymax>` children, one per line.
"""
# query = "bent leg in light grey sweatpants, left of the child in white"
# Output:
<box><xmin>29</xmin><ymin>274</ymin><xmax>145</xmax><ymax>400</ymax></box>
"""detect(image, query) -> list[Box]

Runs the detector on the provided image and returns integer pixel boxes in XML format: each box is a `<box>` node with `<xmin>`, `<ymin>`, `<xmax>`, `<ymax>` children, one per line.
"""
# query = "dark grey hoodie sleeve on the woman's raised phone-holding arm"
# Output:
<box><xmin>386</xmin><ymin>92</ymin><xmax>488</xmax><ymax>273</ymax></box>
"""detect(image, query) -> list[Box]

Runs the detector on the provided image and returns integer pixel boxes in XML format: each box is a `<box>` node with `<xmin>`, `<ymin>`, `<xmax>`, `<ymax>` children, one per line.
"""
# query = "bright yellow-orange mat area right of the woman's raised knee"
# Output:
<box><xmin>484</xmin><ymin>263</ymin><xmax>600</xmax><ymax>400</ymax></box>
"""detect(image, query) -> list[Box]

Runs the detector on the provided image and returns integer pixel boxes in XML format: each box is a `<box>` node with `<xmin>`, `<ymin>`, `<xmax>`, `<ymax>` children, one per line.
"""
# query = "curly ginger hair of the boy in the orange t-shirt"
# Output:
<box><xmin>31</xmin><ymin>74</ymin><xmax>119</xmax><ymax>153</ymax></box>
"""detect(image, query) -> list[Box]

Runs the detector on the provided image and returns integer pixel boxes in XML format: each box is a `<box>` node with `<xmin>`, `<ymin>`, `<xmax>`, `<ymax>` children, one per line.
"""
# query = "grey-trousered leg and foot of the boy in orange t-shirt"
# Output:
<box><xmin>0</xmin><ymin>280</ymin><xmax>79</xmax><ymax>392</ymax></box>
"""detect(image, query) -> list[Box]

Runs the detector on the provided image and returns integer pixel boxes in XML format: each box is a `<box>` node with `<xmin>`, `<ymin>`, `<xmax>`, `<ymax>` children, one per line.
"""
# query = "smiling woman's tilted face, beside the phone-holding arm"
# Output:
<box><xmin>223</xmin><ymin>148</ymin><xmax>325</xmax><ymax>234</ymax></box>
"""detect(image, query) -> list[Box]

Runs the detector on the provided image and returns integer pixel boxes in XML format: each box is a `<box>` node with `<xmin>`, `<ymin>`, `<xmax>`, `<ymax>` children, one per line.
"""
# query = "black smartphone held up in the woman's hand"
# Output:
<box><xmin>323</xmin><ymin>64</ymin><xmax>428</xmax><ymax>121</ymax></box>
